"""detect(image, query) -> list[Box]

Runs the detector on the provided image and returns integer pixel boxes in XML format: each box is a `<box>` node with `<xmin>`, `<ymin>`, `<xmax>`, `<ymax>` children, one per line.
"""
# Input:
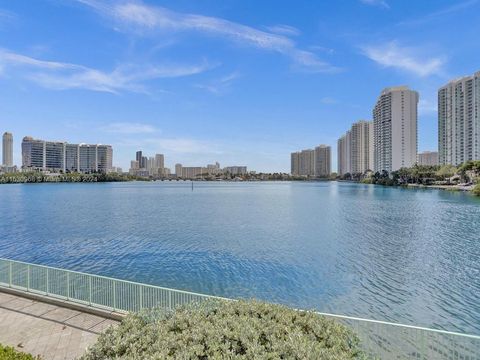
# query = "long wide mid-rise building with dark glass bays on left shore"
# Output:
<box><xmin>22</xmin><ymin>136</ymin><xmax>113</xmax><ymax>173</ymax></box>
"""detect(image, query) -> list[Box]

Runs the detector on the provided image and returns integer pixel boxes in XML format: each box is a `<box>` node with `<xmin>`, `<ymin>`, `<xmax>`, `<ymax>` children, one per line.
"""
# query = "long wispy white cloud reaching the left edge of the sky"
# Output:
<box><xmin>0</xmin><ymin>49</ymin><xmax>212</xmax><ymax>93</ymax></box>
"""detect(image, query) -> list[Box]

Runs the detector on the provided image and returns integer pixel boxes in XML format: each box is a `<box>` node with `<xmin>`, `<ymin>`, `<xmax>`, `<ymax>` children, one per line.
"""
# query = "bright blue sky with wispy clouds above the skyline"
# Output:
<box><xmin>0</xmin><ymin>0</ymin><xmax>480</xmax><ymax>171</ymax></box>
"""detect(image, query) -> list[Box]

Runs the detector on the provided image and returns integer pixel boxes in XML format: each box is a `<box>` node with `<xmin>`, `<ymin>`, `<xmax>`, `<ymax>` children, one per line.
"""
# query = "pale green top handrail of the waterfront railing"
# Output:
<box><xmin>0</xmin><ymin>257</ymin><xmax>480</xmax><ymax>340</ymax></box>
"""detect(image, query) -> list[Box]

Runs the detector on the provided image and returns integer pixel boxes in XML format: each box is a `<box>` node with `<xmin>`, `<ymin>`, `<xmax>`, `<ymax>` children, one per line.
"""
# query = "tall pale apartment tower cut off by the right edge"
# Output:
<box><xmin>438</xmin><ymin>71</ymin><xmax>480</xmax><ymax>166</ymax></box>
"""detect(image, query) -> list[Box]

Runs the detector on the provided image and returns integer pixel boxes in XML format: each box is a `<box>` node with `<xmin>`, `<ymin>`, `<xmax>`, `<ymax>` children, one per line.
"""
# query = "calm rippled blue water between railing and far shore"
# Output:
<box><xmin>0</xmin><ymin>182</ymin><xmax>480</xmax><ymax>334</ymax></box>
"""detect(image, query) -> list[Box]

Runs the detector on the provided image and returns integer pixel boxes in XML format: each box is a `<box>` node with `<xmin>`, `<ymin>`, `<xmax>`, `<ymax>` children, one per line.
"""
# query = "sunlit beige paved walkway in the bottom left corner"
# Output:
<box><xmin>0</xmin><ymin>292</ymin><xmax>118</xmax><ymax>360</ymax></box>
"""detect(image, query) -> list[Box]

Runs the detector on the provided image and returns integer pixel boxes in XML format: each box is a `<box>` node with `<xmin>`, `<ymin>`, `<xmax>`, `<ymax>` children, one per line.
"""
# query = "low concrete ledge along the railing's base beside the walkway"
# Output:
<box><xmin>0</xmin><ymin>286</ymin><xmax>126</xmax><ymax>321</ymax></box>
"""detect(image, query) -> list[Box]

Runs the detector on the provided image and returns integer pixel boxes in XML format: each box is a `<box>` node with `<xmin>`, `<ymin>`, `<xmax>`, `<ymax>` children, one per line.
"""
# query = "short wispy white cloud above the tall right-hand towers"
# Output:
<box><xmin>362</xmin><ymin>41</ymin><xmax>446</xmax><ymax>77</ymax></box>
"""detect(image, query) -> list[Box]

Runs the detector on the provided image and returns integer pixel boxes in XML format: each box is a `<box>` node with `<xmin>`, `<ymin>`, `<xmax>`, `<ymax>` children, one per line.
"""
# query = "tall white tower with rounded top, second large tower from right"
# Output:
<box><xmin>373</xmin><ymin>86</ymin><xmax>418</xmax><ymax>172</ymax></box>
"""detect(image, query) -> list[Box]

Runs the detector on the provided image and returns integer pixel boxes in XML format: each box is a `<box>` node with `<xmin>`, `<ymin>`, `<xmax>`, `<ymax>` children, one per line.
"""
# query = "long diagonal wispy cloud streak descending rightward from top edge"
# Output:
<box><xmin>77</xmin><ymin>0</ymin><xmax>339</xmax><ymax>73</ymax></box>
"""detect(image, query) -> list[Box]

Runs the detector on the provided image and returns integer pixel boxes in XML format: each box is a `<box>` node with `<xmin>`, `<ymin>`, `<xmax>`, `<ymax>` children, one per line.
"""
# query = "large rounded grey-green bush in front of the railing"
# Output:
<box><xmin>82</xmin><ymin>301</ymin><xmax>363</xmax><ymax>360</ymax></box>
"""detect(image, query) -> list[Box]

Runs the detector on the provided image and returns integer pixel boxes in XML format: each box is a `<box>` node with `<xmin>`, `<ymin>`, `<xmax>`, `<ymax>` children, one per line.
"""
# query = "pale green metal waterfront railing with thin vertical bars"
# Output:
<box><xmin>0</xmin><ymin>258</ymin><xmax>480</xmax><ymax>360</ymax></box>
